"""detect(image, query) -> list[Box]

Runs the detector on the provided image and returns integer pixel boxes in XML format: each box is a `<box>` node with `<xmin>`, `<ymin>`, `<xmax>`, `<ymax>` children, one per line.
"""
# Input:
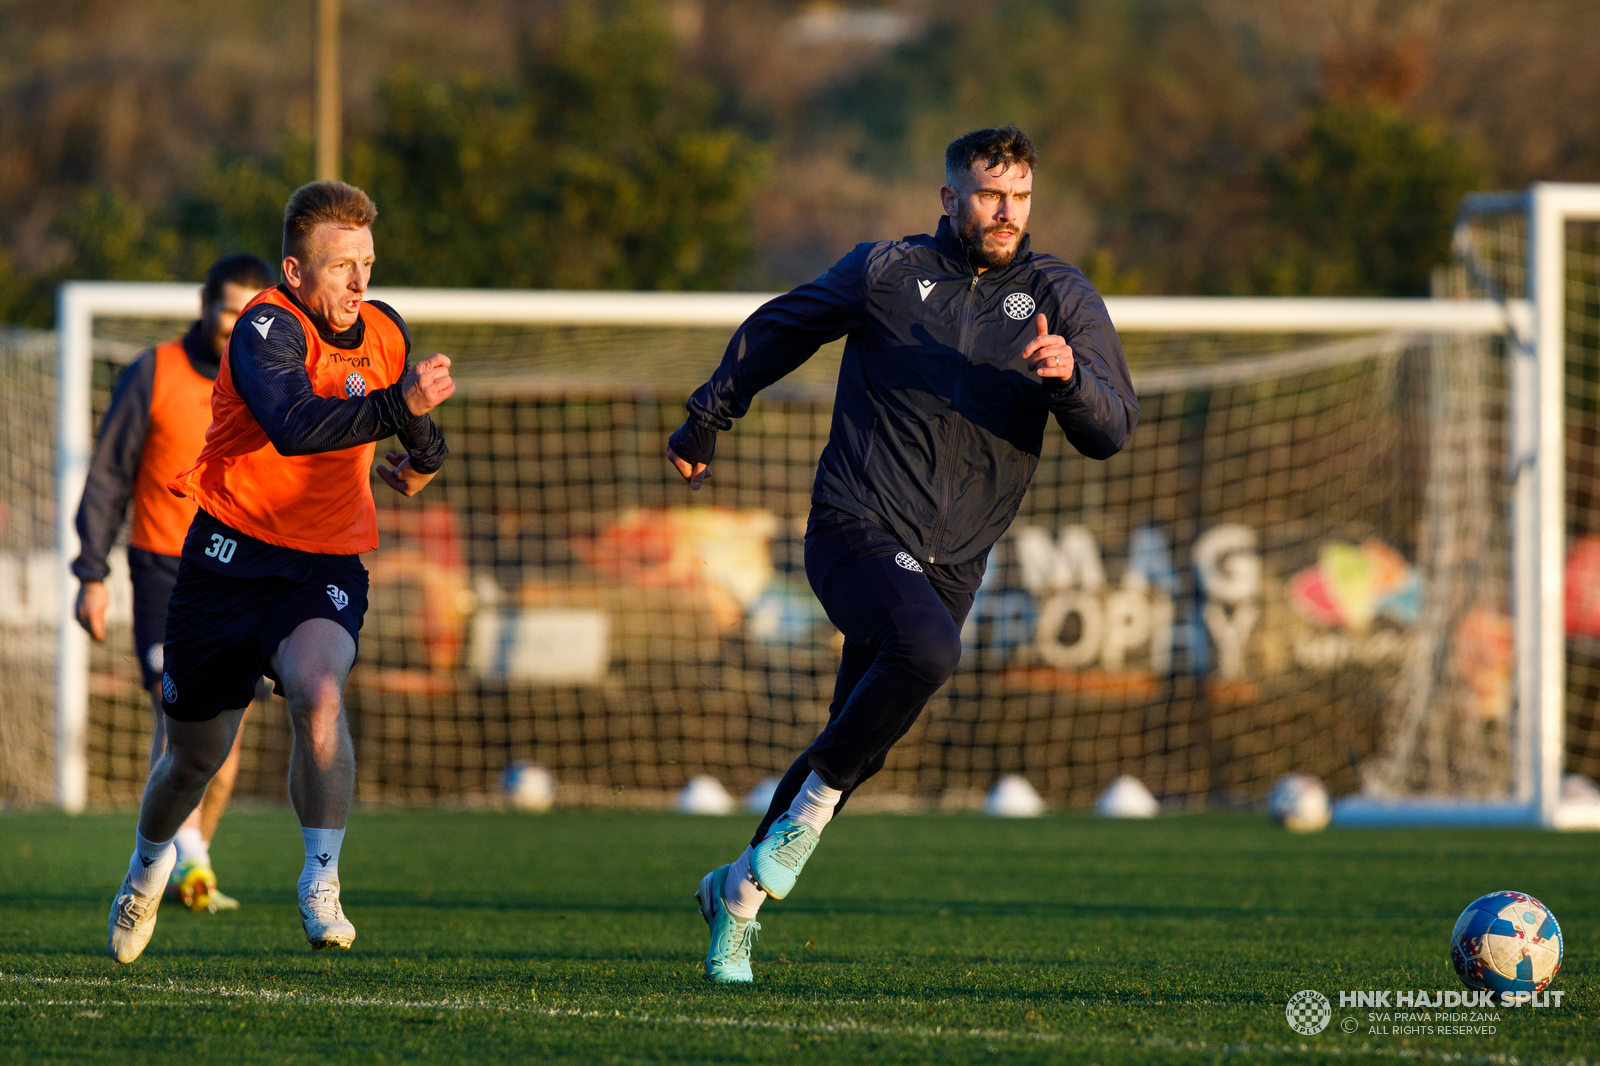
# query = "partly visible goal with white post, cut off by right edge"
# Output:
<box><xmin>1456</xmin><ymin>182</ymin><xmax>1600</xmax><ymax>828</ymax></box>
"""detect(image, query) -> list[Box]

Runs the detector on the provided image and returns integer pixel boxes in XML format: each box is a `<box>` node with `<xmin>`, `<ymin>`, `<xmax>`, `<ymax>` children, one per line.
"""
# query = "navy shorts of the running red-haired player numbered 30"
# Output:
<box><xmin>162</xmin><ymin>555</ymin><xmax>366</xmax><ymax>722</ymax></box>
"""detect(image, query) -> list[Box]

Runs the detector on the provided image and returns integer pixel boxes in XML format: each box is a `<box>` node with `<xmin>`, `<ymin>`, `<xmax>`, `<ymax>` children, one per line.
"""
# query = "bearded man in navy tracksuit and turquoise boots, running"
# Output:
<box><xmin>667</xmin><ymin>126</ymin><xmax>1139</xmax><ymax>981</ymax></box>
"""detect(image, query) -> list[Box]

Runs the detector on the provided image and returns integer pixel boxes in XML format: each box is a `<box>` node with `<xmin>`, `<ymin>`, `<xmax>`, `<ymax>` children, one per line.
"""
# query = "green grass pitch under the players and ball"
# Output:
<box><xmin>0</xmin><ymin>810</ymin><xmax>1600</xmax><ymax>1066</ymax></box>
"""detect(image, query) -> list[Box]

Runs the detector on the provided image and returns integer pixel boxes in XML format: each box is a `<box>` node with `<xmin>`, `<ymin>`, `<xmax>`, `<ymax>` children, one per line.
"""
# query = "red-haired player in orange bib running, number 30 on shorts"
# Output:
<box><xmin>107</xmin><ymin>181</ymin><xmax>456</xmax><ymax>962</ymax></box>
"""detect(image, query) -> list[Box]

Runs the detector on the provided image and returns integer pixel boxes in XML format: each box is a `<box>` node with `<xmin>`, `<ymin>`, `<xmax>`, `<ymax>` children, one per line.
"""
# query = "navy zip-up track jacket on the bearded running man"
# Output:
<box><xmin>670</xmin><ymin>218</ymin><xmax>1139</xmax><ymax>565</ymax></box>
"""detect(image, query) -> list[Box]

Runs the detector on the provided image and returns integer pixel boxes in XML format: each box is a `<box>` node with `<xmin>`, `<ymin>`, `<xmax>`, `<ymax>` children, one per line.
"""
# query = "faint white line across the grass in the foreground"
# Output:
<box><xmin>0</xmin><ymin>973</ymin><xmax>1597</xmax><ymax>1066</ymax></box>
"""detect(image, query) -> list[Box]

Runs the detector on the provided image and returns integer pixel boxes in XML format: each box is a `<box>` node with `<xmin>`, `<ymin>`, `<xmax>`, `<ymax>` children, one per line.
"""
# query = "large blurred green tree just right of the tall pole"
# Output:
<box><xmin>366</xmin><ymin>0</ymin><xmax>766</xmax><ymax>288</ymax></box>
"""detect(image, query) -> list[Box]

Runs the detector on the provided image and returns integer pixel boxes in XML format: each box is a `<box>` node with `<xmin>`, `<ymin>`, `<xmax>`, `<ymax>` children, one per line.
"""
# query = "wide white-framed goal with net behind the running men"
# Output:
<box><xmin>12</xmin><ymin>278</ymin><xmax>1542</xmax><ymax>807</ymax></box>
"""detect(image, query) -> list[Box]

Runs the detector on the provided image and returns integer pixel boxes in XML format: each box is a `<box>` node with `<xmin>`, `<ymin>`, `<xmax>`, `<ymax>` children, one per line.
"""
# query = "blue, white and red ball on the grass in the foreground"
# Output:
<box><xmin>1450</xmin><ymin>892</ymin><xmax>1562</xmax><ymax>992</ymax></box>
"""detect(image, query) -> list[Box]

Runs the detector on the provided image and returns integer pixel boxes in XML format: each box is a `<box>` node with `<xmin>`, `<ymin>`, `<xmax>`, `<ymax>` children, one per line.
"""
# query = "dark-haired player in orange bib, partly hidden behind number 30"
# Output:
<box><xmin>72</xmin><ymin>254</ymin><xmax>272</xmax><ymax>911</ymax></box>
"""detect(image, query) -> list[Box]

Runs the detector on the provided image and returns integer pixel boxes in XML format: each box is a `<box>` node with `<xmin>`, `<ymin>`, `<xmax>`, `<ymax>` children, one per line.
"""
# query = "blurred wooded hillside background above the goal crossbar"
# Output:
<box><xmin>0</xmin><ymin>0</ymin><xmax>1600</xmax><ymax>323</ymax></box>
